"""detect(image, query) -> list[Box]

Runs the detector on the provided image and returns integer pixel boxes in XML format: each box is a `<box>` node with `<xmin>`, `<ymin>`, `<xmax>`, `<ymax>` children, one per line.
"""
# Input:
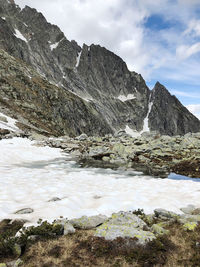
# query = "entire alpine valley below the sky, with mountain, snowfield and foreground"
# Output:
<box><xmin>0</xmin><ymin>0</ymin><xmax>200</xmax><ymax>267</ymax></box>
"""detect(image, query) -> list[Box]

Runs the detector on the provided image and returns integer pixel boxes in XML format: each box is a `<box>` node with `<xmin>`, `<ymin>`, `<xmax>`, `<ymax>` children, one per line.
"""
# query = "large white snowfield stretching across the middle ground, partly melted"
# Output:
<box><xmin>0</xmin><ymin>138</ymin><xmax>200</xmax><ymax>223</ymax></box>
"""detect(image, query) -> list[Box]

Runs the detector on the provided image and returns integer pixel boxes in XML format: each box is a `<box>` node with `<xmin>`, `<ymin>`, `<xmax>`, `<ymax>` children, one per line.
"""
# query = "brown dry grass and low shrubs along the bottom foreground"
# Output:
<box><xmin>0</xmin><ymin>220</ymin><xmax>200</xmax><ymax>267</ymax></box>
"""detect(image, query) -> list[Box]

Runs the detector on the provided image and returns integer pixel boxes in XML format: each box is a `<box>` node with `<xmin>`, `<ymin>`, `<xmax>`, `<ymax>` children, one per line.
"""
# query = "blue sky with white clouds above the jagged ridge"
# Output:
<box><xmin>15</xmin><ymin>0</ymin><xmax>200</xmax><ymax>118</ymax></box>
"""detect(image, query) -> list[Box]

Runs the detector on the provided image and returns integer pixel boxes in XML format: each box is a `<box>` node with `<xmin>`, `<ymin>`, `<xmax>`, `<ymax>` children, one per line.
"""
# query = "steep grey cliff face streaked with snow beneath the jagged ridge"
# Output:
<box><xmin>0</xmin><ymin>0</ymin><xmax>200</xmax><ymax>135</ymax></box>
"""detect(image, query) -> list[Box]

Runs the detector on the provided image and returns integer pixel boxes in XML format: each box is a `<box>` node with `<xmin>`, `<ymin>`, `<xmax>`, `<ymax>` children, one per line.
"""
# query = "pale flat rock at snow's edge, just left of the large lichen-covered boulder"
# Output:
<box><xmin>69</xmin><ymin>215</ymin><xmax>107</xmax><ymax>229</ymax></box>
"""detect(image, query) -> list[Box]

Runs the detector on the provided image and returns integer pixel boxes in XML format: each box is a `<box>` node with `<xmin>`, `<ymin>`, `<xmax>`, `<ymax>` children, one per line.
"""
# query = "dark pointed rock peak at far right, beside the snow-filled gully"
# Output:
<box><xmin>149</xmin><ymin>82</ymin><xmax>199</xmax><ymax>135</ymax></box>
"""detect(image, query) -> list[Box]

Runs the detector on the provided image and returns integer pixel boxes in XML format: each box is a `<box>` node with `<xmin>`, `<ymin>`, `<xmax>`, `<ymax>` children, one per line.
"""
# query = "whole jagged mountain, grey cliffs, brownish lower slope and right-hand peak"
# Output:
<box><xmin>0</xmin><ymin>0</ymin><xmax>200</xmax><ymax>135</ymax></box>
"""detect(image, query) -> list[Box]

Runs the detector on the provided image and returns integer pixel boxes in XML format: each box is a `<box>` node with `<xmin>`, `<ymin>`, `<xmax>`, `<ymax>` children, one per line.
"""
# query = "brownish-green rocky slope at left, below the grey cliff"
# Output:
<box><xmin>0</xmin><ymin>50</ymin><xmax>111</xmax><ymax>136</ymax></box>
